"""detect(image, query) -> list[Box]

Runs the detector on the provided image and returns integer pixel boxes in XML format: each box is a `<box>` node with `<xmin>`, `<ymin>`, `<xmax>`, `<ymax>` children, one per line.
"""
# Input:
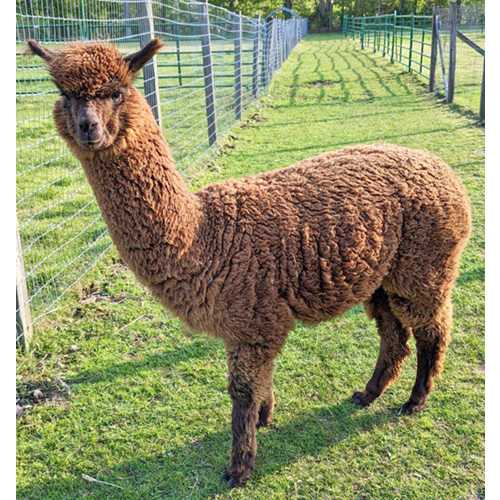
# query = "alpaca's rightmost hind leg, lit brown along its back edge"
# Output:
<box><xmin>403</xmin><ymin>299</ymin><xmax>452</xmax><ymax>413</ymax></box>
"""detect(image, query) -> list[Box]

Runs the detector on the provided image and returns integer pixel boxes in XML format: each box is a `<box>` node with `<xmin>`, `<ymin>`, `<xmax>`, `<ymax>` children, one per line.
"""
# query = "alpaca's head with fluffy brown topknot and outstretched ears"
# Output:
<box><xmin>28</xmin><ymin>39</ymin><xmax>163</xmax><ymax>150</ymax></box>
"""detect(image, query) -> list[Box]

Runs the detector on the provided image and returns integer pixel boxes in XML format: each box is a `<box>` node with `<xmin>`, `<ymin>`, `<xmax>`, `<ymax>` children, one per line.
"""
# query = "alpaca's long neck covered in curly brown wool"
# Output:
<box><xmin>79</xmin><ymin>94</ymin><xmax>202</xmax><ymax>285</ymax></box>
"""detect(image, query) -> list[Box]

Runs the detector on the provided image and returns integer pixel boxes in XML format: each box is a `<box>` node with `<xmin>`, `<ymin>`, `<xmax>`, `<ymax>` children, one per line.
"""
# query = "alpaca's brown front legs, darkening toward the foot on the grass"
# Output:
<box><xmin>222</xmin><ymin>345</ymin><xmax>275</xmax><ymax>488</ymax></box>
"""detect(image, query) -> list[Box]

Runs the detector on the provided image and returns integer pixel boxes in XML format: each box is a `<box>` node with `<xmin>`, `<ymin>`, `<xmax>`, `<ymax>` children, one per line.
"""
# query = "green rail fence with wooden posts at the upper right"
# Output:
<box><xmin>342</xmin><ymin>2</ymin><xmax>485</xmax><ymax>120</ymax></box>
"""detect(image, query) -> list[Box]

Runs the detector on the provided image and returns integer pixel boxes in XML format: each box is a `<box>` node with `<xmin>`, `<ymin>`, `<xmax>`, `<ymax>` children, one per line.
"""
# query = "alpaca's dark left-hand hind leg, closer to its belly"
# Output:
<box><xmin>353</xmin><ymin>288</ymin><xmax>411</xmax><ymax>406</ymax></box>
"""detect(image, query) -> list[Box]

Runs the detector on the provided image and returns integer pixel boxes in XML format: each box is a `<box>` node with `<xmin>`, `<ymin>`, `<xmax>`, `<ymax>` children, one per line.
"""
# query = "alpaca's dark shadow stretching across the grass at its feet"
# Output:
<box><xmin>18</xmin><ymin>399</ymin><xmax>399</xmax><ymax>499</ymax></box>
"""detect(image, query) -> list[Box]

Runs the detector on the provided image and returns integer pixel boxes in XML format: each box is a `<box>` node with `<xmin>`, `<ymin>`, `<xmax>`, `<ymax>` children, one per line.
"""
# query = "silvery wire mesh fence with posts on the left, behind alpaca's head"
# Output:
<box><xmin>16</xmin><ymin>0</ymin><xmax>307</xmax><ymax>344</ymax></box>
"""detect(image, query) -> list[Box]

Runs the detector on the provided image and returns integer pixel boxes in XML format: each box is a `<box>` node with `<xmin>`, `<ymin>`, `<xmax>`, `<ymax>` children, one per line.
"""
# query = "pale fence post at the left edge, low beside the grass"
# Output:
<box><xmin>16</xmin><ymin>220</ymin><xmax>33</xmax><ymax>348</ymax></box>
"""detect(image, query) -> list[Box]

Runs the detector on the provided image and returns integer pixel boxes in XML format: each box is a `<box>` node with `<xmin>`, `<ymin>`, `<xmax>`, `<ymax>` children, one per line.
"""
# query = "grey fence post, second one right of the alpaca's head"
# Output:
<box><xmin>198</xmin><ymin>0</ymin><xmax>217</xmax><ymax>146</ymax></box>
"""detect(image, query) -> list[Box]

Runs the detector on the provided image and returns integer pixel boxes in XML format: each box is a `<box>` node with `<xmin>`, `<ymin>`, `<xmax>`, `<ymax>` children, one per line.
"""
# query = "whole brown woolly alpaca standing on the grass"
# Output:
<box><xmin>29</xmin><ymin>40</ymin><xmax>471</xmax><ymax>486</ymax></box>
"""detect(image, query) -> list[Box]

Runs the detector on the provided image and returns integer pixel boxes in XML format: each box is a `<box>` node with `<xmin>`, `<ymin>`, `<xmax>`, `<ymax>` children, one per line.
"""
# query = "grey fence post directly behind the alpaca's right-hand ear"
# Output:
<box><xmin>137</xmin><ymin>0</ymin><xmax>161</xmax><ymax>128</ymax></box>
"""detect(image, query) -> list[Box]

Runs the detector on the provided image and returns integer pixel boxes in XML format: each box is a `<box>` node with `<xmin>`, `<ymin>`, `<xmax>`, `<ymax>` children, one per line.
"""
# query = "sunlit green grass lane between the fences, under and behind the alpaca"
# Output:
<box><xmin>17</xmin><ymin>35</ymin><xmax>484</xmax><ymax>500</ymax></box>
